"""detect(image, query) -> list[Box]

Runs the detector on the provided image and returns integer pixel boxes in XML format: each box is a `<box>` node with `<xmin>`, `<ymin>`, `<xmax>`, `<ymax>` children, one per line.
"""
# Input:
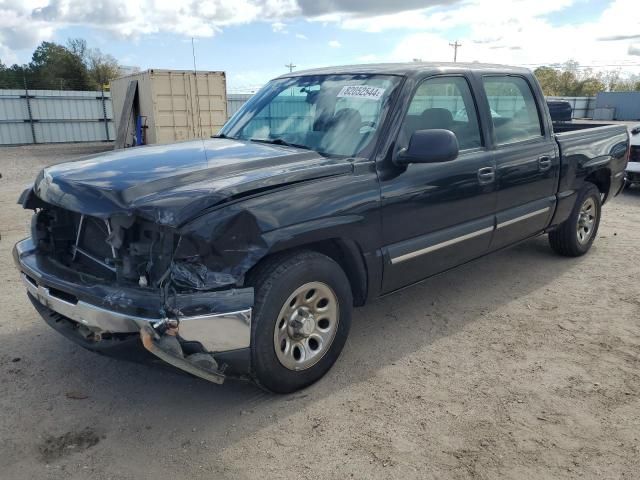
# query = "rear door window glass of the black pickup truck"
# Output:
<box><xmin>483</xmin><ymin>77</ymin><xmax>543</xmax><ymax>145</ymax></box>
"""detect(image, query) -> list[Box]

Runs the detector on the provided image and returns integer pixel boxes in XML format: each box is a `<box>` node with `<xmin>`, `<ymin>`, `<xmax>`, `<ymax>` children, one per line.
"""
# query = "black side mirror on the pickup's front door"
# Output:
<box><xmin>395</xmin><ymin>129</ymin><xmax>460</xmax><ymax>165</ymax></box>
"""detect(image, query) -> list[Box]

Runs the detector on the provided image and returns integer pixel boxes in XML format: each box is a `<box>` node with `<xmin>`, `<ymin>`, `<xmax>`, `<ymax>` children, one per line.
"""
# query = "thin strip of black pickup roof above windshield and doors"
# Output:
<box><xmin>278</xmin><ymin>62</ymin><xmax>531</xmax><ymax>78</ymax></box>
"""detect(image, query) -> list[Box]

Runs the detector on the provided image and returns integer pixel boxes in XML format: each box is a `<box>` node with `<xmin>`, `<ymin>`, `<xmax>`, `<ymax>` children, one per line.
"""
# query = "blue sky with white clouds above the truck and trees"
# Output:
<box><xmin>0</xmin><ymin>0</ymin><xmax>640</xmax><ymax>91</ymax></box>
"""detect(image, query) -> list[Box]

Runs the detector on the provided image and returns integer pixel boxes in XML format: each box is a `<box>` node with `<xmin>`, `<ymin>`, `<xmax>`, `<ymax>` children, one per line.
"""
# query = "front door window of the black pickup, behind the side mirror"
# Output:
<box><xmin>398</xmin><ymin>77</ymin><xmax>482</xmax><ymax>150</ymax></box>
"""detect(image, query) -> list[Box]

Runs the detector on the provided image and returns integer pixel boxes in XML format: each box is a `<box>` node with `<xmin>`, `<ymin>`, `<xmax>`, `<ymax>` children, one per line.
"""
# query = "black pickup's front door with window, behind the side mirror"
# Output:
<box><xmin>380</xmin><ymin>75</ymin><xmax>495</xmax><ymax>292</ymax></box>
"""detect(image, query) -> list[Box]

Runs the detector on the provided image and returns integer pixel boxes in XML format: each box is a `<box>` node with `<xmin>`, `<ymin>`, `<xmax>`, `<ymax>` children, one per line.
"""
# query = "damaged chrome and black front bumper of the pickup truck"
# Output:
<box><xmin>13</xmin><ymin>238</ymin><xmax>253</xmax><ymax>383</ymax></box>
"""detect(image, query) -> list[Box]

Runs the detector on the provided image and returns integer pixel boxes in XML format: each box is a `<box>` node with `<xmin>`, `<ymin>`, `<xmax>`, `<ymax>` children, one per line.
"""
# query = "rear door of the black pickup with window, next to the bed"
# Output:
<box><xmin>482</xmin><ymin>75</ymin><xmax>560</xmax><ymax>250</ymax></box>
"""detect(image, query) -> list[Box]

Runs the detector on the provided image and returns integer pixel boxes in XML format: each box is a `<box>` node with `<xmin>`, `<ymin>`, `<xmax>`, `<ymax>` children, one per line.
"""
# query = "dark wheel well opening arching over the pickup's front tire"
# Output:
<box><xmin>245</xmin><ymin>238</ymin><xmax>368</xmax><ymax>306</ymax></box>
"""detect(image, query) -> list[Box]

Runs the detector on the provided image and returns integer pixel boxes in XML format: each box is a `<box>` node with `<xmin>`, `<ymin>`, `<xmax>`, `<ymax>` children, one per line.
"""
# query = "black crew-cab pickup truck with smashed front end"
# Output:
<box><xmin>14</xmin><ymin>63</ymin><xmax>629</xmax><ymax>392</ymax></box>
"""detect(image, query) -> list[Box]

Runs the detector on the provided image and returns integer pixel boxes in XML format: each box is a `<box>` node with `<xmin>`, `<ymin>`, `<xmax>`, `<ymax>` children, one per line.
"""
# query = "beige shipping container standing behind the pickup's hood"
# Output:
<box><xmin>111</xmin><ymin>70</ymin><xmax>227</xmax><ymax>145</ymax></box>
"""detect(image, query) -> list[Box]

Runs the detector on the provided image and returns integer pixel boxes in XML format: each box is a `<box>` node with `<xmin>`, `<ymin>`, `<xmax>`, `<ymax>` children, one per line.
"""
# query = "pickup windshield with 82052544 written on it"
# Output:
<box><xmin>220</xmin><ymin>75</ymin><xmax>400</xmax><ymax>156</ymax></box>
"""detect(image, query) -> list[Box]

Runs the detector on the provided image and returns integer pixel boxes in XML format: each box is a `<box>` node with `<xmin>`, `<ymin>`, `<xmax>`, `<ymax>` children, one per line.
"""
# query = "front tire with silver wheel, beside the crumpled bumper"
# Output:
<box><xmin>247</xmin><ymin>251</ymin><xmax>353</xmax><ymax>393</ymax></box>
